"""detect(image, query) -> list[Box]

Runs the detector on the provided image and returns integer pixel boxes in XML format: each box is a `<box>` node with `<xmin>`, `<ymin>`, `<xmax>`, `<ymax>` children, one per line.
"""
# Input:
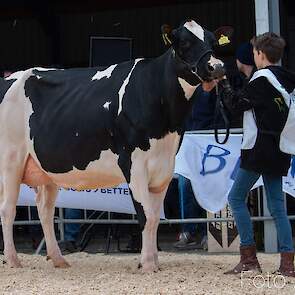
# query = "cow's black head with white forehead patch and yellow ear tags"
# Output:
<box><xmin>162</xmin><ymin>20</ymin><xmax>233</xmax><ymax>85</ymax></box>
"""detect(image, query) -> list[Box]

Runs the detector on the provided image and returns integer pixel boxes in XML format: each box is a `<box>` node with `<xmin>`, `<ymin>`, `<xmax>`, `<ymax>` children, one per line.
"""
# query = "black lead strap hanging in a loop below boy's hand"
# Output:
<box><xmin>214</xmin><ymin>84</ymin><xmax>230</xmax><ymax>144</ymax></box>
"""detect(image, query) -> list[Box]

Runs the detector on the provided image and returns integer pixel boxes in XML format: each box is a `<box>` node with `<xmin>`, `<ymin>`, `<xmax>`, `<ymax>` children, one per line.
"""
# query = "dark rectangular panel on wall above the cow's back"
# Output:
<box><xmin>89</xmin><ymin>37</ymin><xmax>132</xmax><ymax>67</ymax></box>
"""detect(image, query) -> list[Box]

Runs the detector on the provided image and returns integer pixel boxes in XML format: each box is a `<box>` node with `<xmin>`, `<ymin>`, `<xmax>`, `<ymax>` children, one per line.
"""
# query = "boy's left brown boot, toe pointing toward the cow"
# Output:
<box><xmin>224</xmin><ymin>245</ymin><xmax>262</xmax><ymax>275</ymax></box>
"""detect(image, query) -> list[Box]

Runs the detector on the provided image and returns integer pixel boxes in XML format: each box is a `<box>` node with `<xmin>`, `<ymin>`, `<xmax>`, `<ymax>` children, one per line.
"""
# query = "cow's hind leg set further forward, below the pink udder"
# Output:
<box><xmin>36</xmin><ymin>184</ymin><xmax>70</xmax><ymax>268</ymax></box>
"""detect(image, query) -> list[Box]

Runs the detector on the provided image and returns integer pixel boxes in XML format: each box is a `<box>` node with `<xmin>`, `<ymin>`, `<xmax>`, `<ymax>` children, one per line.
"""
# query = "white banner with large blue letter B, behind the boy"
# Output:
<box><xmin>175</xmin><ymin>134</ymin><xmax>295</xmax><ymax>213</ymax></box>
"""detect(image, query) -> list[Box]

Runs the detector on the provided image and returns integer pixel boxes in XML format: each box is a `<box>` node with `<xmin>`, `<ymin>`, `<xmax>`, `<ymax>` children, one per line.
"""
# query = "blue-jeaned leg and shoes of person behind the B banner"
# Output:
<box><xmin>178</xmin><ymin>175</ymin><xmax>207</xmax><ymax>238</ymax></box>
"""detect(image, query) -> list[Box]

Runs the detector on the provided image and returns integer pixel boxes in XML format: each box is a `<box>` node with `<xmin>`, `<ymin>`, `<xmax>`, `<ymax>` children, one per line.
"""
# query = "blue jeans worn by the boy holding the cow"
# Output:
<box><xmin>228</xmin><ymin>168</ymin><xmax>294</xmax><ymax>252</ymax></box>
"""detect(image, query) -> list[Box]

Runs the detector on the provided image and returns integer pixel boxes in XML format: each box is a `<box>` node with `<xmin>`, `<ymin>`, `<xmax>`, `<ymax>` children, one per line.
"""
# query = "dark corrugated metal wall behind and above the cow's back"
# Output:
<box><xmin>0</xmin><ymin>0</ymin><xmax>255</xmax><ymax>68</ymax></box>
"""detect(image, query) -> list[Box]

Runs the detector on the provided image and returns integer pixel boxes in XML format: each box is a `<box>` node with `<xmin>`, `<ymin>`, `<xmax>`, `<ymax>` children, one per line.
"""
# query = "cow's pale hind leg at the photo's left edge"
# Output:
<box><xmin>0</xmin><ymin>165</ymin><xmax>22</xmax><ymax>267</ymax></box>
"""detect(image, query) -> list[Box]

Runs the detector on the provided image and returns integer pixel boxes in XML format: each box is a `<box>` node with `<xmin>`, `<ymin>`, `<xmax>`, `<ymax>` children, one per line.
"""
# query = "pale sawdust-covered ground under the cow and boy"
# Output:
<box><xmin>0</xmin><ymin>251</ymin><xmax>295</xmax><ymax>295</ymax></box>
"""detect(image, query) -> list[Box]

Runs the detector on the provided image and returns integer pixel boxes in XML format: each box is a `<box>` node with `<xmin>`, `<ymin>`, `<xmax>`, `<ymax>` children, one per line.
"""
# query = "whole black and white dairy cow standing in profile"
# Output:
<box><xmin>0</xmin><ymin>20</ymin><xmax>231</xmax><ymax>271</ymax></box>
